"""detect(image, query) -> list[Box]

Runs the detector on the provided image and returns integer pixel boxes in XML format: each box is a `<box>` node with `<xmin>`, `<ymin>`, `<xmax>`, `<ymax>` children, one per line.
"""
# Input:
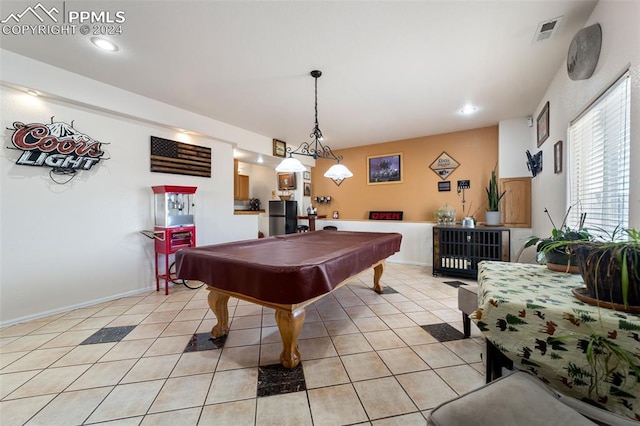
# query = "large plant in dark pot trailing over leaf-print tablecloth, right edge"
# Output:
<box><xmin>544</xmin><ymin>226</ymin><xmax>640</xmax><ymax>416</ymax></box>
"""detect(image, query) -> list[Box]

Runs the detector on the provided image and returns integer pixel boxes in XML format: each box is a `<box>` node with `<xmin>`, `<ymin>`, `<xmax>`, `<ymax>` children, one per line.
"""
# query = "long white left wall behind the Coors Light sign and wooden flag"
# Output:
<box><xmin>0</xmin><ymin>50</ymin><xmax>262</xmax><ymax>325</ymax></box>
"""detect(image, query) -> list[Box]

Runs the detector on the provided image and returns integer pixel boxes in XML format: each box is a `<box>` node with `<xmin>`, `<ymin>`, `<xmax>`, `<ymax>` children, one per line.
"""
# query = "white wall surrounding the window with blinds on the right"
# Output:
<box><xmin>529</xmin><ymin>1</ymin><xmax>640</xmax><ymax>235</ymax></box>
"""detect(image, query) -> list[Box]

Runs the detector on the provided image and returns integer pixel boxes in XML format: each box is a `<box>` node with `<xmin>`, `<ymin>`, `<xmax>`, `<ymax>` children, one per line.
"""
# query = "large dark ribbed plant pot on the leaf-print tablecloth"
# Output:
<box><xmin>571</xmin><ymin>244</ymin><xmax>640</xmax><ymax>306</ymax></box>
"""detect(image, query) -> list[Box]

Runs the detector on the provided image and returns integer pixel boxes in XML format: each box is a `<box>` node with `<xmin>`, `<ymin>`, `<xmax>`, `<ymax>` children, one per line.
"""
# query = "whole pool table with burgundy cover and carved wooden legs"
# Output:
<box><xmin>176</xmin><ymin>230</ymin><xmax>402</xmax><ymax>368</ymax></box>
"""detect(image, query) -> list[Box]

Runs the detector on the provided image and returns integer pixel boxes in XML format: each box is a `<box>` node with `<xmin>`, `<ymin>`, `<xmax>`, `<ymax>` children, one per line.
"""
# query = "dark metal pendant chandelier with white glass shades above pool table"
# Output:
<box><xmin>276</xmin><ymin>70</ymin><xmax>353</xmax><ymax>185</ymax></box>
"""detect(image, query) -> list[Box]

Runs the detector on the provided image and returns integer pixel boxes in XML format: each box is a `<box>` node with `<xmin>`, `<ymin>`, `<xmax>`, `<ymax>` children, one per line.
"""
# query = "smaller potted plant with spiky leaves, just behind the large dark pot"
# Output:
<box><xmin>524</xmin><ymin>207</ymin><xmax>593</xmax><ymax>274</ymax></box>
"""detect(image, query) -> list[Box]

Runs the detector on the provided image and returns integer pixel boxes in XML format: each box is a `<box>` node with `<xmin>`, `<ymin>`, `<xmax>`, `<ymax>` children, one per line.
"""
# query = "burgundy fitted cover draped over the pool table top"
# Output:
<box><xmin>176</xmin><ymin>231</ymin><xmax>402</xmax><ymax>304</ymax></box>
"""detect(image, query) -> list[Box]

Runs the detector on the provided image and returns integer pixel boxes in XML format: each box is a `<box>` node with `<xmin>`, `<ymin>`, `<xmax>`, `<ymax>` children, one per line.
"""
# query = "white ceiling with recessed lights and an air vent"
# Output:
<box><xmin>0</xmin><ymin>0</ymin><xmax>596</xmax><ymax>153</ymax></box>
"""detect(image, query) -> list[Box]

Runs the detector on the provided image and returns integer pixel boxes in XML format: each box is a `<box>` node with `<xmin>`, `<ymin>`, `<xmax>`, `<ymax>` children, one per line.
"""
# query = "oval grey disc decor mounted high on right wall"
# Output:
<box><xmin>567</xmin><ymin>24</ymin><xmax>602</xmax><ymax>80</ymax></box>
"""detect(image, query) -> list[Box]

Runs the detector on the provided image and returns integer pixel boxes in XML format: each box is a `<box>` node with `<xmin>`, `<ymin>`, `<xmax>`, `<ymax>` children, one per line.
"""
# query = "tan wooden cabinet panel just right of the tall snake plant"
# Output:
<box><xmin>500</xmin><ymin>177</ymin><xmax>531</xmax><ymax>228</ymax></box>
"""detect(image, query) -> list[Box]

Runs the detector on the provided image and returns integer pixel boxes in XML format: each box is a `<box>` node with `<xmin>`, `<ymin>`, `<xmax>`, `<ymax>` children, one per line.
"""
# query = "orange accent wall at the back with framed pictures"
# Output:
<box><xmin>311</xmin><ymin>126</ymin><xmax>498</xmax><ymax>222</ymax></box>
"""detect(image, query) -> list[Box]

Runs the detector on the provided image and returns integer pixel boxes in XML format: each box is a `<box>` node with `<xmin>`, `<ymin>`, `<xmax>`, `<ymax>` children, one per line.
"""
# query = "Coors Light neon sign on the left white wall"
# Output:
<box><xmin>9</xmin><ymin>117</ymin><xmax>105</xmax><ymax>181</ymax></box>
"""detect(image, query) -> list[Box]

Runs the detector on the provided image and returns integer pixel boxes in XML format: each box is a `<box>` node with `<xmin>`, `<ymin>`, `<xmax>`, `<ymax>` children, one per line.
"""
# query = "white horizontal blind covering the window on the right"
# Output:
<box><xmin>567</xmin><ymin>71</ymin><xmax>631</xmax><ymax>235</ymax></box>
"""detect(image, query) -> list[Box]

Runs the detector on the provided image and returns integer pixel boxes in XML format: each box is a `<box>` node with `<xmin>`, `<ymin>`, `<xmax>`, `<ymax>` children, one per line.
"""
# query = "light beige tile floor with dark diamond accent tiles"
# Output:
<box><xmin>0</xmin><ymin>263</ymin><xmax>484</xmax><ymax>426</ymax></box>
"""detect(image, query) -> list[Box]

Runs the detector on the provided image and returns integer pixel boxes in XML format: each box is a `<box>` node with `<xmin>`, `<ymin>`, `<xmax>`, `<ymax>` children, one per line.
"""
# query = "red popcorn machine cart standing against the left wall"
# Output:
<box><xmin>152</xmin><ymin>185</ymin><xmax>197</xmax><ymax>294</ymax></box>
